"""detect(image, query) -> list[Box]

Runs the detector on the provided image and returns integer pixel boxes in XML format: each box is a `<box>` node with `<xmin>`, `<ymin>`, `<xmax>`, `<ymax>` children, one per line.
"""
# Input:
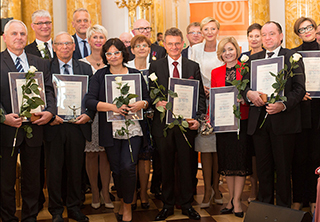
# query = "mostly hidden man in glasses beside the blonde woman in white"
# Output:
<box><xmin>181</xmin><ymin>22</ymin><xmax>203</xmax><ymax>59</ymax></box>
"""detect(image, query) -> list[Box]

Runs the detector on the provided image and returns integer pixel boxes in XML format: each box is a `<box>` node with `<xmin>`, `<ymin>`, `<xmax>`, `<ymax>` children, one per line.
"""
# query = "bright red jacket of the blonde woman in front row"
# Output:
<box><xmin>211</xmin><ymin>61</ymin><xmax>249</xmax><ymax>120</ymax></box>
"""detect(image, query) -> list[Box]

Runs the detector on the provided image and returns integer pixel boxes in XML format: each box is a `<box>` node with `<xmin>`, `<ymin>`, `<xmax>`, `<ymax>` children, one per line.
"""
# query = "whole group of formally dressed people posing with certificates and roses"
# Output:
<box><xmin>0</xmin><ymin>8</ymin><xmax>320</xmax><ymax>222</ymax></box>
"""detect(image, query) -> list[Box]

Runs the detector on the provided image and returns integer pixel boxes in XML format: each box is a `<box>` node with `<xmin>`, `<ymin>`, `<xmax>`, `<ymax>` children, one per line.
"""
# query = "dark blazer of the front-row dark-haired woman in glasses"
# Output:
<box><xmin>84</xmin><ymin>66</ymin><xmax>150</xmax><ymax>147</ymax></box>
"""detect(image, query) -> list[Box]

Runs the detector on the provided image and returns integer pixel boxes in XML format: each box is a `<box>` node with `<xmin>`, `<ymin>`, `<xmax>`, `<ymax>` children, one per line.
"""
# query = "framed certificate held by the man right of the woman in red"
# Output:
<box><xmin>250</xmin><ymin>56</ymin><xmax>284</xmax><ymax>99</ymax></box>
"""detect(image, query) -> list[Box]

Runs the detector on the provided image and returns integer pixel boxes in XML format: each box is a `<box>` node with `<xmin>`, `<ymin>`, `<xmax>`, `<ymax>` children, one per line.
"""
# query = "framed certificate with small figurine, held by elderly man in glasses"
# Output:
<box><xmin>52</xmin><ymin>74</ymin><xmax>89</xmax><ymax>122</ymax></box>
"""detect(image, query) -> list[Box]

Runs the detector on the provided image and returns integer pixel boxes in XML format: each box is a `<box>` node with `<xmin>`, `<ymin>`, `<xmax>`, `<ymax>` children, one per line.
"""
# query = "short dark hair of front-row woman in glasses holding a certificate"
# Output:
<box><xmin>100</xmin><ymin>38</ymin><xmax>129</xmax><ymax>66</ymax></box>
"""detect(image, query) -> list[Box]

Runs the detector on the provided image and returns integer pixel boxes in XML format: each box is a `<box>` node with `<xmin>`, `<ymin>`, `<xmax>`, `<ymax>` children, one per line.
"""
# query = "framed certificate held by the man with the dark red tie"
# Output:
<box><xmin>166</xmin><ymin>78</ymin><xmax>199</xmax><ymax>124</ymax></box>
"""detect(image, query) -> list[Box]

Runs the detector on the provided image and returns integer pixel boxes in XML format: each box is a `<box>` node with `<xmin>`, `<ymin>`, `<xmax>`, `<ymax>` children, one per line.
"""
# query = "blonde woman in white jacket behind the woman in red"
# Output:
<box><xmin>191</xmin><ymin>17</ymin><xmax>223</xmax><ymax>208</ymax></box>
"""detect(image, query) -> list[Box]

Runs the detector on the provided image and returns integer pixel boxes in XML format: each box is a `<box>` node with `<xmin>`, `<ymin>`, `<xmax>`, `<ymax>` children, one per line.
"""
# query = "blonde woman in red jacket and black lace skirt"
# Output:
<box><xmin>211</xmin><ymin>37</ymin><xmax>252</xmax><ymax>217</ymax></box>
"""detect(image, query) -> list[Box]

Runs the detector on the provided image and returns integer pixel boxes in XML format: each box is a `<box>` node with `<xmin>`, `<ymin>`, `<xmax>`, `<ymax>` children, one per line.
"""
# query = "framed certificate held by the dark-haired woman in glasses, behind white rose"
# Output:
<box><xmin>105</xmin><ymin>73</ymin><xmax>143</xmax><ymax>122</ymax></box>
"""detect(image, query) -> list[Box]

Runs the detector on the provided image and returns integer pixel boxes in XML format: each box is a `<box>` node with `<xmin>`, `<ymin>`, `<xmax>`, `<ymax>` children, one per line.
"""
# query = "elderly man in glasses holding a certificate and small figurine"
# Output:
<box><xmin>44</xmin><ymin>32</ymin><xmax>94</xmax><ymax>222</ymax></box>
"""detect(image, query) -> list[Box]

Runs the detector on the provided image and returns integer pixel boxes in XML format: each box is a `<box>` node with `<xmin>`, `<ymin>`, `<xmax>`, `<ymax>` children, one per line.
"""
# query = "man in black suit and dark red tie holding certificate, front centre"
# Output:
<box><xmin>149</xmin><ymin>28</ymin><xmax>206</xmax><ymax>220</ymax></box>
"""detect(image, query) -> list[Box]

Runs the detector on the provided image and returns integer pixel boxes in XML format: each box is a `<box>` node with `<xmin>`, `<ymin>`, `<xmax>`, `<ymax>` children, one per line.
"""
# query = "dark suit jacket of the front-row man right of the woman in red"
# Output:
<box><xmin>242</xmin><ymin>48</ymin><xmax>306</xmax><ymax>135</ymax></box>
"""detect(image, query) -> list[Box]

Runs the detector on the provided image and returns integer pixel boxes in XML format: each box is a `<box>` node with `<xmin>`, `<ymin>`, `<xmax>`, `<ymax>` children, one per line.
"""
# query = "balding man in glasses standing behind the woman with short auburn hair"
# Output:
<box><xmin>128</xmin><ymin>19</ymin><xmax>166</xmax><ymax>63</ymax></box>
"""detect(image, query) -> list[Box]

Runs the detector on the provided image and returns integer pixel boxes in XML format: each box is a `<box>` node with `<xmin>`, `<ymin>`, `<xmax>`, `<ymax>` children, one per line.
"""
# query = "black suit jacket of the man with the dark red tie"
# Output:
<box><xmin>149</xmin><ymin>57</ymin><xmax>206</xmax><ymax>137</ymax></box>
